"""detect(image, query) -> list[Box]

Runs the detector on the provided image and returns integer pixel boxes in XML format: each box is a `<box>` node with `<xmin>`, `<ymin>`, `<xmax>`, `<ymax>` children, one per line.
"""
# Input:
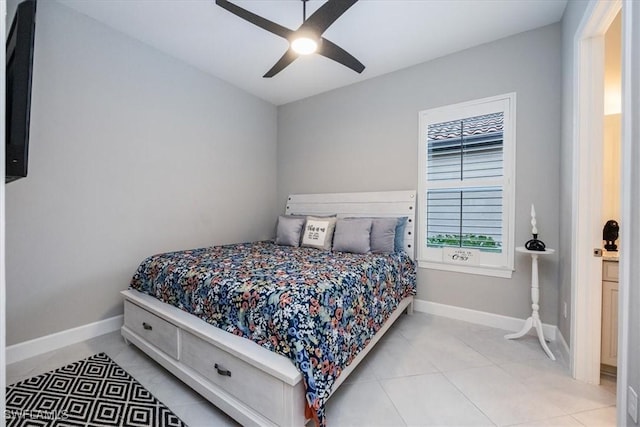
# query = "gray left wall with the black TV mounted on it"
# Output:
<box><xmin>6</xmin><ymin>1</ymin><xmax>280</xmax><ymax>345</ymax></box>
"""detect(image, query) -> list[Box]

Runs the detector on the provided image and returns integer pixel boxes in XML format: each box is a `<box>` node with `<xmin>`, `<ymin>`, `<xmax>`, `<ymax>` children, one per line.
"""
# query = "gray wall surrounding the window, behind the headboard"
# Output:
<box><xmin>278</xmin><ymin>24</ymin><xmax>562</xmax><ymax>324</ymax></box>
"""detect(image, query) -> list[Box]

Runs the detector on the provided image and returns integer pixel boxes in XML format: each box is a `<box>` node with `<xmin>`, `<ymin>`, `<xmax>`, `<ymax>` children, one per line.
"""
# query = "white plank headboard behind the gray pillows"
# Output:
<box><xmin>285</xmin><ymin>191</ymin><xmax>416</xmax><ymax>259</ymax></box>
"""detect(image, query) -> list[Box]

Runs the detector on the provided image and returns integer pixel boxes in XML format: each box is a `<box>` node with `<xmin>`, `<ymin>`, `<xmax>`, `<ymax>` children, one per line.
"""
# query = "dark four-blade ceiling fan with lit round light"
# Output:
<box><xmin>216</xmin><ymin>0</ymin><xmax>364</xmax><ymax>78</ymax></box>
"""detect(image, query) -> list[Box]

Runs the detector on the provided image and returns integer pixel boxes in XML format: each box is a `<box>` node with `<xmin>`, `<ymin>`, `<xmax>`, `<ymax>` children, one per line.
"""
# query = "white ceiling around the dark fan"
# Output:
<box><xmin>53</xmin><ymin>0</ymin><xmax>567</xmax><ymax>105</ymax></box>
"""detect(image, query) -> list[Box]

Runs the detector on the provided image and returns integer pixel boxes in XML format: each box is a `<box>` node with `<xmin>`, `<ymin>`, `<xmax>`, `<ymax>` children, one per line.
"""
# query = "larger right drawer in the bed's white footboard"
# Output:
<box><xmin>181</xmin><ymin>331</ymin><xmax>284</xmax><ymax>425</ymax></box>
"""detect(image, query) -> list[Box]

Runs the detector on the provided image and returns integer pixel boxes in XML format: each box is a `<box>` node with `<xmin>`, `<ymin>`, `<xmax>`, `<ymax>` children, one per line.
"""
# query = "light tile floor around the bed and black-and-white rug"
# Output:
<box><xmin>7</xmin><ymin>313</ymin><xmax>616</xmax><ymax>427</ymax></box>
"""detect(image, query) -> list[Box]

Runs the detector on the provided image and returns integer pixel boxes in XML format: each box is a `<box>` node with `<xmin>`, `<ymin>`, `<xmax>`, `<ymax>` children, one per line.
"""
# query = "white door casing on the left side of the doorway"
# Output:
<box><xmin>570</xmin><ymin>0</ymin><xmax>624</xmax><ymax>384</ymax></box>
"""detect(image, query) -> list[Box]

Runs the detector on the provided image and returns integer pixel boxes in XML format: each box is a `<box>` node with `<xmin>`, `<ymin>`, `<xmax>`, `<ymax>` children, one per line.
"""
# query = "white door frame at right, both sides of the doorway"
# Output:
<box><xmin>571</xmin><ymin>0</ymin><xmax>640</xmax><ymax>425</ymax></box>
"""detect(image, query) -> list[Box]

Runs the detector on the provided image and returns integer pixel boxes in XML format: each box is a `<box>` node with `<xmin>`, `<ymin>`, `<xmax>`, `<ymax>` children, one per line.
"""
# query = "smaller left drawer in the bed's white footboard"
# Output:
<box><xmin>124</xmin><ymin>301</ymin><xmax>178</xmax><ymax>359</ymax></box>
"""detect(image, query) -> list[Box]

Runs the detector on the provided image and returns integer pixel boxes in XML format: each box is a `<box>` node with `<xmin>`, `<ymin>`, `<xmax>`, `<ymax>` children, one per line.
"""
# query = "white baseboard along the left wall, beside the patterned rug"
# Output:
<box><xmin>5</xmin><ymin>315</ymin><xmax>124</xmax><ymax>364</ymax></box>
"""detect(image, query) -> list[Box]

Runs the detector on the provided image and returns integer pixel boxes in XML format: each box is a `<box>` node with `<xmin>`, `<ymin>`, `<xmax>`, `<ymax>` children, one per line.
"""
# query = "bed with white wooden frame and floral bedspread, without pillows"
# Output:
<box><xmin>122</xmin><ymin>191</ymin><xmax>415</xmax><ymax>426</ymax></box>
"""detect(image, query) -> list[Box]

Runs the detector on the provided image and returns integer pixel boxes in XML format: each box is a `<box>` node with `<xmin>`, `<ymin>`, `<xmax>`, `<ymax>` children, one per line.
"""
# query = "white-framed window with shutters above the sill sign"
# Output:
<box><xmin>418</xmin><ymin>93</ymin><xmax>516</xmax><ymax>277</ymax></box>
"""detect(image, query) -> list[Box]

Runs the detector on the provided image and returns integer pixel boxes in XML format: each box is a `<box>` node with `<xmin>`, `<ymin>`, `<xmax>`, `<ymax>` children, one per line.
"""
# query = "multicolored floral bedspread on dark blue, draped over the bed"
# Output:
<box><xmin>131</xmin><ymin>241</ymin><xmax>416</xmax><ymax>424</ymax></box>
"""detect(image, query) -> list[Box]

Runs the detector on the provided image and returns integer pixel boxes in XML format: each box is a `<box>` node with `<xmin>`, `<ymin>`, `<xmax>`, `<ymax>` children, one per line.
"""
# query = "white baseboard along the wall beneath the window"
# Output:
<box><xmin>413</xmin><ymin>299</ymin><xmax>566</xmax><ymax>345</ymax></box>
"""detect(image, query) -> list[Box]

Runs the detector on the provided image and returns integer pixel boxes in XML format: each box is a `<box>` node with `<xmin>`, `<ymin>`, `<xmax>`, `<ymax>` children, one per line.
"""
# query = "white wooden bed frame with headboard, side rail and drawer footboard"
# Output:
<box><xmin>121</xmin><ymin>191</ymin><xmax>416</xmax><ymax>426</ymax></box>
